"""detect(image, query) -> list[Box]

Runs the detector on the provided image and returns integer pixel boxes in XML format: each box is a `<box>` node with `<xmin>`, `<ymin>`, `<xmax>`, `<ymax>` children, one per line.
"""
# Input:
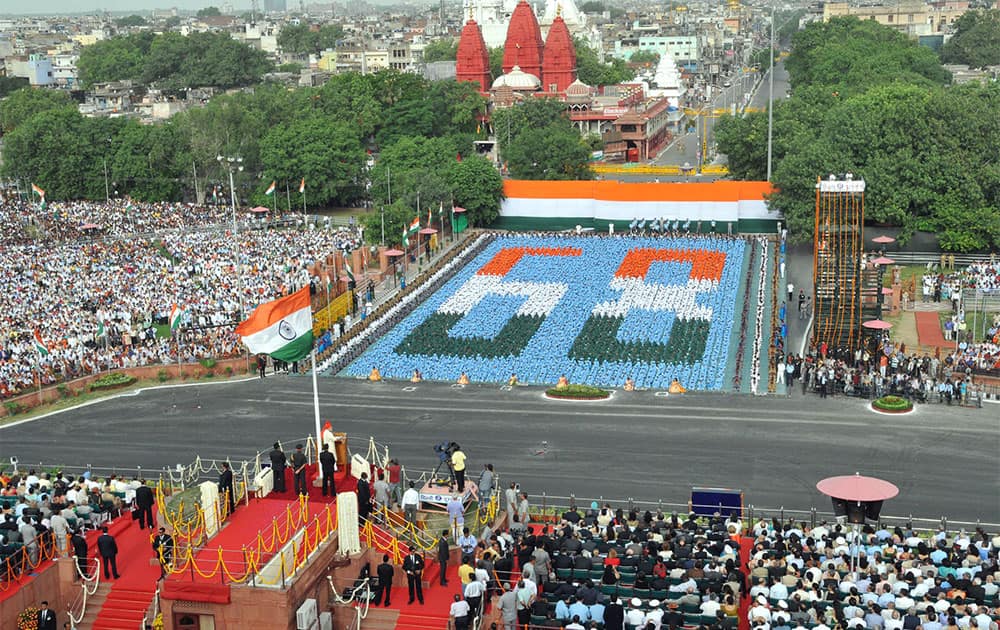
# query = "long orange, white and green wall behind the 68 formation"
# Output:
<box><xmin>500</xmin><ymin>179</ymin><xmax>781</xmax><ymax>233</ymax></box>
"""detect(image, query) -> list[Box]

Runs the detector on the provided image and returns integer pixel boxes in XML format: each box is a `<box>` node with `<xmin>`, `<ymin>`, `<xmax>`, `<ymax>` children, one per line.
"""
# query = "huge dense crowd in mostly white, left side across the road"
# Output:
<box><xmin>0</xmin><ymin>221</ymin><xmax>368</xmax><ymax>398</ymax></box>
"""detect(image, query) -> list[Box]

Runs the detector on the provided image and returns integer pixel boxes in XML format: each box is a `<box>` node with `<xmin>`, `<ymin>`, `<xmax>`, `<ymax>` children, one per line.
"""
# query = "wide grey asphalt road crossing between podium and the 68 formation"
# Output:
<box><xmin>0</xmin><ymin>375</ymin><xmax>1000</xmax><ymax>523</ymax></box>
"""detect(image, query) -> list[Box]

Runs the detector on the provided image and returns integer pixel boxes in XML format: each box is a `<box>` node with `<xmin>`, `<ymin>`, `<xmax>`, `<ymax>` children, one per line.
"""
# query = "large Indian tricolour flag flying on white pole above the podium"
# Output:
<box><xmin>236</xmin><ymin>285</ymin><xmax>313</xmax><ymax>361</ymax></box>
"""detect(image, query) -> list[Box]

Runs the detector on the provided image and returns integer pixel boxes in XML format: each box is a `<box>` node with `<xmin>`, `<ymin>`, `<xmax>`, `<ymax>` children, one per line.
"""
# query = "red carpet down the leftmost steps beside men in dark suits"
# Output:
<box><xmin>87</xmin><ymin>513</ymin><xmax>160</xmax><ymax>630</ymax></box>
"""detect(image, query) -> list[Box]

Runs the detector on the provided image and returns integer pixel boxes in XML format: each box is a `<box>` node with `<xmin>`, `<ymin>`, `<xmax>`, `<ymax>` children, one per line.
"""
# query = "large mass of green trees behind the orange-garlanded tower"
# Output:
<box><xmin>716</xmin><ymin>18</ymin><xmax>1000</xmax><ymax>251</ymax></box>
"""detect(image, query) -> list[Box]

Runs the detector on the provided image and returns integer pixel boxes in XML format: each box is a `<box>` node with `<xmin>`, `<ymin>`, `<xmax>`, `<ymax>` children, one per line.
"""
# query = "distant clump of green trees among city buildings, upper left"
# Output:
<box><xmin>77</xmin><ymin>31</ymin><xmax>273</xmax><ymax>92</ymax></box>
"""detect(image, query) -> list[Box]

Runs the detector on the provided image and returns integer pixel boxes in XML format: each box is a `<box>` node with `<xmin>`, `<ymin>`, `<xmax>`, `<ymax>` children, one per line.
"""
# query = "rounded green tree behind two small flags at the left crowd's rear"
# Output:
<box><xmin>258</xmin><ymin>116</ymin><xmax>365</xmax><ymax>210</ymax></box>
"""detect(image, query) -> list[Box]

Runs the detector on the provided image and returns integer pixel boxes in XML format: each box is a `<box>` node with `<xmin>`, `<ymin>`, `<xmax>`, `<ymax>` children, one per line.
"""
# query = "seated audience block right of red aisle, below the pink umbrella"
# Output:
<box><xmin>747</xmin><ymin>520</ymin><xmax>1000</xmax><ymax>630</ymax></box>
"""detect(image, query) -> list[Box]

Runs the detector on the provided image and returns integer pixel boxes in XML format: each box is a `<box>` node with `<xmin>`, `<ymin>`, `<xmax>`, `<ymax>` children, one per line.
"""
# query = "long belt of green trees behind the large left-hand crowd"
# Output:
<box><xmin>0</xmin><ymin>70</ymin><xmax>502</xmax><ymax>225</ymax></box>
